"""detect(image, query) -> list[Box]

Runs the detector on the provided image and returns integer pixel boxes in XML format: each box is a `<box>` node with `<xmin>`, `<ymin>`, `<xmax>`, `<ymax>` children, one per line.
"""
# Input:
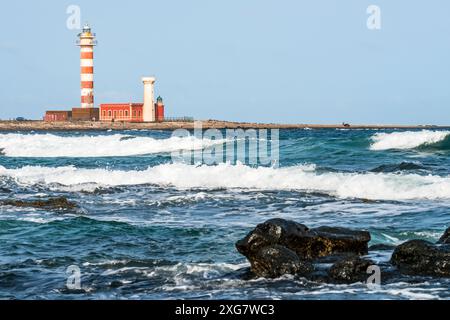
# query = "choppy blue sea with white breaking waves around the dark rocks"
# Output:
<box><xmin>0</xmin><ymin>128</ymin><xmax>450</xmax><ymax>300</ymax></box>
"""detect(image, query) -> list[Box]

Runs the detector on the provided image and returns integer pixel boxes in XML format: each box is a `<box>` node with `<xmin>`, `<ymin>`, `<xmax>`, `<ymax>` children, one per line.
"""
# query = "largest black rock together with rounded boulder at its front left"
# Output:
<box><xmin>236</xmin><ymin>219</ymin><xmax>370</xmax><ymax>278</ymax></box>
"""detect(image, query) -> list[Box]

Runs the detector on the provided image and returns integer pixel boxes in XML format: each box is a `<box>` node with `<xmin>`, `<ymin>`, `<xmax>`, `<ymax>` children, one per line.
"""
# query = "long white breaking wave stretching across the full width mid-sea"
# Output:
<box><xmin>0</xmin><ymin>163</ymin><xmax>450</xmax><ymax>200</ymax></box>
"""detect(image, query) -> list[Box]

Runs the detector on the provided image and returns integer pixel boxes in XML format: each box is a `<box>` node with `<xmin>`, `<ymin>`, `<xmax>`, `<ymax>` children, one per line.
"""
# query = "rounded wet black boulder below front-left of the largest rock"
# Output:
<box><xmin>249</xmin><ymin>245</ymin><xmax>313</xmax><ymax>278</ymax></box>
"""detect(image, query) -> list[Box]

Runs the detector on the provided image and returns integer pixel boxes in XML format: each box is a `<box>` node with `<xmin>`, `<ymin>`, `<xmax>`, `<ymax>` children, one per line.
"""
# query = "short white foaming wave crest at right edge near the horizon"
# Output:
<box><xmin>370</xmin><ymin>130</ymin><xmax>450</xmax><ymax>150</ymax></box>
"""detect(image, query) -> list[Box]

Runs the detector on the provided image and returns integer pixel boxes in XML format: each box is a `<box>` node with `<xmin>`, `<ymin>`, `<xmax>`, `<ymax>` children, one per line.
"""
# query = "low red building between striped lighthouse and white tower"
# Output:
<box><xmin>100</xmin><ymin>103</ymin><xmax>144</xmax><ymax>122</ymax></box>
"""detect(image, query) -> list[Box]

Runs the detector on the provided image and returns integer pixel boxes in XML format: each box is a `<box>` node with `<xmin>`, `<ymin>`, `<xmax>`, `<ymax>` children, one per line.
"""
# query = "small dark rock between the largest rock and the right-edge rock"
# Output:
<box><xmin>328</xmin><ymin>256</ymin><xmax>375</xmax><ymax>283</ymax></box>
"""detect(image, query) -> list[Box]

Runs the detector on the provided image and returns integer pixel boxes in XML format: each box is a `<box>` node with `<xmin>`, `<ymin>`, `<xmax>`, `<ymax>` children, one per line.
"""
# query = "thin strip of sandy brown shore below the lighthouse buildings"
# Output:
<box><xmin>0</xmin><ymin>120</ymin><xmax>450</xmax><ymax>131</ymax></box>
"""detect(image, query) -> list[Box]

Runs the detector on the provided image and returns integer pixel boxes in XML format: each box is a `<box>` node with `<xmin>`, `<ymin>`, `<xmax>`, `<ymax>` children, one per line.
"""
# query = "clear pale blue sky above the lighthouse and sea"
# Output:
<box><xmin>0</xmin><ymin>0</ymin><xmax>450</xmax><ymax>125</ymax></box>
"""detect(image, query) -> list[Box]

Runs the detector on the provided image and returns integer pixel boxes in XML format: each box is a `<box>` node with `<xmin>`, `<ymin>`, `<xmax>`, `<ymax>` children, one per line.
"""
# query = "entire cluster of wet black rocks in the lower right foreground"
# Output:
<box><xmin>236</xmin><ymin>219</ymin><xmax>450</xmax><ymax>284</ymax></box>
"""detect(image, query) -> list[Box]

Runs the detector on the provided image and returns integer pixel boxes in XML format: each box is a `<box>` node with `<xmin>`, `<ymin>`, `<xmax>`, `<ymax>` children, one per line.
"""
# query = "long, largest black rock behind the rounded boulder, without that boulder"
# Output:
<box><xmin>236</xmin><ymin>219</ymin><xmax>370</xmax><ymax>259</ymax></box>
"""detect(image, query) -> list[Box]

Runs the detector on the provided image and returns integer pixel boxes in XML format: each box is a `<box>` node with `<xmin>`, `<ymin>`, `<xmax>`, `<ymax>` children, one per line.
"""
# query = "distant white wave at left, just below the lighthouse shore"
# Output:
<box><xmin>0</xmin><ymin>133</ymin><xmax>226</xmax><ymax>158</ymax></box>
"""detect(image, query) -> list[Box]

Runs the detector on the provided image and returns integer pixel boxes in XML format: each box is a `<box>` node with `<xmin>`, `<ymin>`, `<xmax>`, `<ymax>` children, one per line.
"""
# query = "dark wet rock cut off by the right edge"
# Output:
<box><xmin>391</xmin><ymin>240</ymin><xmax>450</xmax><ymax>277</ymax></box>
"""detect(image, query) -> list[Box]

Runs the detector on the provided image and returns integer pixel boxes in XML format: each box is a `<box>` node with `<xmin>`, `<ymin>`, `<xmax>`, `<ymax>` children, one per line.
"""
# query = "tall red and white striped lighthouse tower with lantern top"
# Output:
<box><xmin>77</xmin><ymin>24</ymin><xmax>97</xmax><ymax>108</ymax></box>
